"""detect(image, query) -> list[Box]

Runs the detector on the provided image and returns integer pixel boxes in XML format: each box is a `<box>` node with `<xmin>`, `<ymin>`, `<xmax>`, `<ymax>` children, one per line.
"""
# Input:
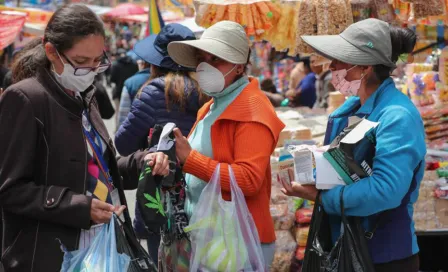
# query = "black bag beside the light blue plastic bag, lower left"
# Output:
<box><xmin>112</xmin><ymin>216</ymin><xmax>158</xmax><ymax>272</ymax></box>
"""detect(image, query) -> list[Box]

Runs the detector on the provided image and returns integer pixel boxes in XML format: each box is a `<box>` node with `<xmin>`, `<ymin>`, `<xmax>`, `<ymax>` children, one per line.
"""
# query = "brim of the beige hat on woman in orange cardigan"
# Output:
<box><xmin>168</xmin><ymin>39</ymin><xmax>244</xmax><ymax>68</ymax></box>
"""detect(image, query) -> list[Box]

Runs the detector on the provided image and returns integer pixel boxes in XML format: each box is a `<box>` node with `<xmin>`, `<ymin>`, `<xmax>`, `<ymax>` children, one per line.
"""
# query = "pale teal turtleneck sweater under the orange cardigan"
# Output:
<box><xmin>185</xmin><ymin>76</ymin><xmax>249</xmax><ymax>217</ymax></box>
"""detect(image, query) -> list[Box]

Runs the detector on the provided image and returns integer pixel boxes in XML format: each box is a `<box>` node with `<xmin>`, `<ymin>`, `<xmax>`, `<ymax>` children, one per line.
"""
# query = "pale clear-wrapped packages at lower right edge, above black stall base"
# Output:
<box><xmin>414</xmin><ymin>170</ymin><xmax>448</xmax><ymax>231</ymax></box>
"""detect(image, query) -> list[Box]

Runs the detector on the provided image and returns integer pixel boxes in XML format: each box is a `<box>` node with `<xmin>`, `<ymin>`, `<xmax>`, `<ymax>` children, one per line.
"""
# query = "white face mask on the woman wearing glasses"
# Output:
<box><xmin>53</xmin><ymin>53</ymin><xmax>97</xmax><ymax>92</ymax></box>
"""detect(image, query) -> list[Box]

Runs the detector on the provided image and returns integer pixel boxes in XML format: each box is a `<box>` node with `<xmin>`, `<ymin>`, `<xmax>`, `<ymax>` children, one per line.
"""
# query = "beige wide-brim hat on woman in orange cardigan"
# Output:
<box><xmin>168</xmin><ymin>21</ymin><xmax>249</xmax><ymax>68</ymax></box>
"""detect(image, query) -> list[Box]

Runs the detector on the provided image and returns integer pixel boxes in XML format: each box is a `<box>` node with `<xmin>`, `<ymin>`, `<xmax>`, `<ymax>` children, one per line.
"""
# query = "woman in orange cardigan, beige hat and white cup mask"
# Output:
<box><xmin>168</xmin><ymin>21</ymin><xmax>284</xmax><ymax>266</ymax></box>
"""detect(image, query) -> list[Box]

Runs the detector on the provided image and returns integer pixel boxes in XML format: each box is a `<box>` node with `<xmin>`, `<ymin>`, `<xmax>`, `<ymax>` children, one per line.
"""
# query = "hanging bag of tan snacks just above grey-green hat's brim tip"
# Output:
<box><xmin>296</xmin><ymin>0</ymin><xmax>317</xmax><ymax>53</ymax></box>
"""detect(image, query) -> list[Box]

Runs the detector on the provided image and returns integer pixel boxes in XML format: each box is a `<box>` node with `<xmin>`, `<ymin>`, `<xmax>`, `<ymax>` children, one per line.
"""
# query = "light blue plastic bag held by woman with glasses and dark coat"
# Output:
<box><xmin>61</xmin><ymin>215</ymin><xmax>131</xmax><ymax>272</ymax></box>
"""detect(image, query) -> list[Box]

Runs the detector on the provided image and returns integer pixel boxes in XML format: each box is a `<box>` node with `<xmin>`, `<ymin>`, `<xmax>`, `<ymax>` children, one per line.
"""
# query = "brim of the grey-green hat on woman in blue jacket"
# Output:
<box><xmin>301</xmin><ymin>35</ymin><xmax>381</xmax><ymax>65</ymax></box>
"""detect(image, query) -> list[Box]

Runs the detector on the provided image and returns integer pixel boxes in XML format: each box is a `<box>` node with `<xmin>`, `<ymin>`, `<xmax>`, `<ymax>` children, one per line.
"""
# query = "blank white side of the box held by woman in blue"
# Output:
<box><xmin>313</xmin><ymin>151</ymin><xmax>345</xmax><ymax>190</ymax></box>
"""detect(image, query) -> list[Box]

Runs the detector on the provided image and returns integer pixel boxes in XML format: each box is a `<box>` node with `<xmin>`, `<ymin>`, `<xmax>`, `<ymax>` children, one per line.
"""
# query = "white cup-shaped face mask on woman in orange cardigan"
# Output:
<box><xmin>196</xmin><ymin>62</ymin><xmax>236</xmax><ymax>96</ymax></box>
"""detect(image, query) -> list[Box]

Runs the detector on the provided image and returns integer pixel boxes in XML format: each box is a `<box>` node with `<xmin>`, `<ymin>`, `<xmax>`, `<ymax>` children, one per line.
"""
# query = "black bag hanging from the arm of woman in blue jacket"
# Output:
<box><xmin>302</xmin><ymin>187</ymin><xmax>375</xmax><ymax>272</ymax></box>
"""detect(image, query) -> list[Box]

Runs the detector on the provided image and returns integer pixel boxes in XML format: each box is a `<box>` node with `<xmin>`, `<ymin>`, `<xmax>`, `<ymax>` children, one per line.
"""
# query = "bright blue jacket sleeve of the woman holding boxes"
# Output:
<box><xmin>322</xmin><ymin>106</ymin><xmax>426</xmax><ymax>216</ymax></box>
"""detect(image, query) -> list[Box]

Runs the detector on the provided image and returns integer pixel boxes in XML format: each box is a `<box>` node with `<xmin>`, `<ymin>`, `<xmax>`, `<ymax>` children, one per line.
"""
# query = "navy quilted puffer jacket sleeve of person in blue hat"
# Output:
<box><xmin>115</xmin><ymin>84</ymin><xmax>160</xmax><ymax>156</ymax></box>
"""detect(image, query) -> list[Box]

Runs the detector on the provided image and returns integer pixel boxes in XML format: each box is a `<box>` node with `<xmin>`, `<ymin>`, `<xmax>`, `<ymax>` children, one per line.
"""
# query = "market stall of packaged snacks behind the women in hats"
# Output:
<box><xmin>194</xmin><ymin>0</ymin><xmax>448</xmax><ymax>271</ymax></box>
